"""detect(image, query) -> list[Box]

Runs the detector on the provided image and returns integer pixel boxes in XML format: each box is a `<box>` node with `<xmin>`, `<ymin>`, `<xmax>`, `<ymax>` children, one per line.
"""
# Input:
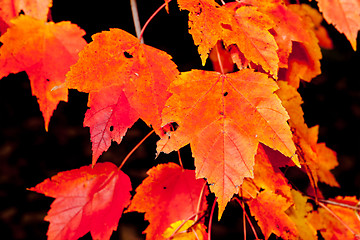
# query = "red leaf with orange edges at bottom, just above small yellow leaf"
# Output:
<box><xmin>127</xmin><ymin>163</ymin><xmax>208</xmax><ymax>239</ymax></box>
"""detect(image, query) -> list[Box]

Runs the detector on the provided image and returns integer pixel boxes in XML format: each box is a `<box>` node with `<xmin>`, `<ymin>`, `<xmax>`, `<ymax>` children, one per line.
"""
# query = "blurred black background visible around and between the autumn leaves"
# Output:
<box><xmin>0</xmin><ymin>0</ymin><xmax>360</xmax><ymax>240</ymax></box>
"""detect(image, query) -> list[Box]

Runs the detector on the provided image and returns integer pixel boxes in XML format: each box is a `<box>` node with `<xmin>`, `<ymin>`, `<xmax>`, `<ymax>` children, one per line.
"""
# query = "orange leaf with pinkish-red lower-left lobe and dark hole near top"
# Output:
<box><xmin>66</xmin><ymin>29</ymin><xmax>178</xmax><ymax>164</ymax></box>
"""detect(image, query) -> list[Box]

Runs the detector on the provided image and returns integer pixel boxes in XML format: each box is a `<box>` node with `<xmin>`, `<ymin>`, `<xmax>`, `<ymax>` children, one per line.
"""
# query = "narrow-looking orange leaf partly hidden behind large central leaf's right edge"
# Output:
<box><xmin>276</xmin><ymin>81</ymin><xmax>340</xmax><ymax>188</ymax></box>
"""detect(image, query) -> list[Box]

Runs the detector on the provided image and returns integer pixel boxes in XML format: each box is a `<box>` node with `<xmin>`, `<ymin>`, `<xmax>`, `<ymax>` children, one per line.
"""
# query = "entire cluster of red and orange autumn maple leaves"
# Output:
<box><xmin>0</xmin><ymin>0</ymin><xmax>360</xmax><ymax>240</ymax></box>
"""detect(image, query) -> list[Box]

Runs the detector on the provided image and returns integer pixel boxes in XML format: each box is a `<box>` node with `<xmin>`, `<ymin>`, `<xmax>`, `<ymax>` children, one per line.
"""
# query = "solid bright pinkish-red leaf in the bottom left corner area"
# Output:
<box><xmin>30</xmin><ymin>162</ymin><xmax>131</xmax><ymax>240</ymax></box>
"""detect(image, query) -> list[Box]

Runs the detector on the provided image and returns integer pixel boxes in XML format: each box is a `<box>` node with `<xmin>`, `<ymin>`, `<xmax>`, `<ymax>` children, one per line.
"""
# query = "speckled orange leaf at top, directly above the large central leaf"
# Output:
<box><xmin>178</xmin><ymin>0</ymin><xmax>279</xmax><ymax>75</ymax></box>
